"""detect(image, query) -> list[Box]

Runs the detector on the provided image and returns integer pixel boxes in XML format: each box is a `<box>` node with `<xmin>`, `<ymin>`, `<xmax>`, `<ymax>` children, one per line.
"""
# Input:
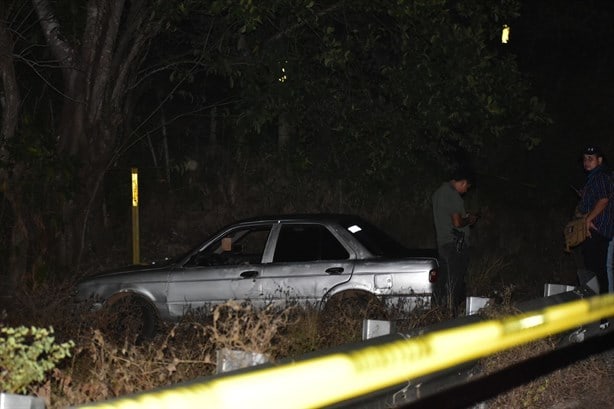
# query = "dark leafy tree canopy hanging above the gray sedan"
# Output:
<box><xmin>150</xmin><ymin>0</ymin><xmax>547</xmax><ymax>183</ymax></box>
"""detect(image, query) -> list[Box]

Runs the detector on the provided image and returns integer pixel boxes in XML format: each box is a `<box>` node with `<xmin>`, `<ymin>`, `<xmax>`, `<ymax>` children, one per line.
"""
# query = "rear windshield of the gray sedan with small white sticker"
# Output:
<box><xmin>341</xmin><ymin>219</ymin><xmax>410</xmax><ymax>257</ymax></box>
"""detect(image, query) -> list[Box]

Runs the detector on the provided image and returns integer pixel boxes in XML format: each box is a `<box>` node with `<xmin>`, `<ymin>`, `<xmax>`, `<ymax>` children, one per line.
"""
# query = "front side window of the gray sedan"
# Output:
<box><xmin>189</xmin><ymin>226</ymin><xmax>271</xmax><ymax>266</ymax></box>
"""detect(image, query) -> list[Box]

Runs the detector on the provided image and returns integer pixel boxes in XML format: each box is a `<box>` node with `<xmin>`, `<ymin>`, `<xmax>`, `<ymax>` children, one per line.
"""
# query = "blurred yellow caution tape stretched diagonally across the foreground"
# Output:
<box><xmin>80</xmin><ymin>294</ymin><xmax>614</xmax><ymax>409</ymax></box>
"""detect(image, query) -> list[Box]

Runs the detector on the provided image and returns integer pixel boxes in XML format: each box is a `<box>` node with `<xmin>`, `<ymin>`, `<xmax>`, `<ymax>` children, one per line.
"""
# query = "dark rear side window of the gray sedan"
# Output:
<box><xmin>273</xmin><ymin>224</ymin><xmax>350</xmax><ymax>262</ymax></box>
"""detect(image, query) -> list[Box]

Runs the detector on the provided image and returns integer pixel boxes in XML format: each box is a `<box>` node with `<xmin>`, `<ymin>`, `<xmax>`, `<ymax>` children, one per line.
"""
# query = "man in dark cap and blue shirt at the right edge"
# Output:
<box><xmin>578</xmin><ymin>146</ymin><xmax>614</xmax><ymax>294</ymax></box>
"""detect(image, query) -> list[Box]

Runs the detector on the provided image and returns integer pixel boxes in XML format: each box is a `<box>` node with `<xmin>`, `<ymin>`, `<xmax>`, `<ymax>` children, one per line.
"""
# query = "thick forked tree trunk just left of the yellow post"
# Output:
<box><xmin>32</xmin><ymin>0</ymin><xmax>161</xmax><ymax>268</ymax></box>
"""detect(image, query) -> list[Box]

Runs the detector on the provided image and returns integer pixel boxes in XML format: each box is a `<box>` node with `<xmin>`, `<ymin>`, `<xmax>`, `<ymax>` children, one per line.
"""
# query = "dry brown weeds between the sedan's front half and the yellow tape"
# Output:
<box><xmin>25</xmin><ymin>302</ymin><xmax>294</xmax><ymax>408</ymax></box>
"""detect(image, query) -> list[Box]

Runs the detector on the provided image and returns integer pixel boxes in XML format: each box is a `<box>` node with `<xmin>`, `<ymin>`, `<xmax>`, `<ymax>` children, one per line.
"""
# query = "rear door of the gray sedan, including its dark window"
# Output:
<box><xmin>260</xmin><ymin>222</ymin><xmax>354</xmax><ymax>303</ymax></box>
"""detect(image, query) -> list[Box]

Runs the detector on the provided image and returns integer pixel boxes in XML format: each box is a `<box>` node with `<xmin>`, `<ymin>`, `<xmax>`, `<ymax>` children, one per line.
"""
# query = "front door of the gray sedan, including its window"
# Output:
<box><xmin>168</xmin><ymin>224</ymin><xmax>271</xmax><ymax>317</ymax></box>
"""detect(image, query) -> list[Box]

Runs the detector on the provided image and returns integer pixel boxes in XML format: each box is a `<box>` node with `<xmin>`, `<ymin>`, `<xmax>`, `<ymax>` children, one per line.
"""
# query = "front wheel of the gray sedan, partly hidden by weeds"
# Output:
<box><xmin>101</xmin><ymin>295</ymin><xmax>158</xmax><ymax>344</ymax></box>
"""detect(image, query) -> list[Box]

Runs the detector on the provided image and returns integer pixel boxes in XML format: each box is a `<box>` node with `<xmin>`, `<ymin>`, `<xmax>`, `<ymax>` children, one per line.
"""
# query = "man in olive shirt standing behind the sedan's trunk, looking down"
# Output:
<box><xmin>432</xmin><ymin>170</ymin><xmax>477</xmax><ymax>315</ymax></box>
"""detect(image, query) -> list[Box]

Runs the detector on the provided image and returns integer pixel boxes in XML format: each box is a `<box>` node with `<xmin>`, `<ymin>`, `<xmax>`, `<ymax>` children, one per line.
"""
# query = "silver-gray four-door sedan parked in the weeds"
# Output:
<box><xmin>77</xmin><ymin>214</ymin><xmax>438</xmax><ymax>336</ymax></box>
